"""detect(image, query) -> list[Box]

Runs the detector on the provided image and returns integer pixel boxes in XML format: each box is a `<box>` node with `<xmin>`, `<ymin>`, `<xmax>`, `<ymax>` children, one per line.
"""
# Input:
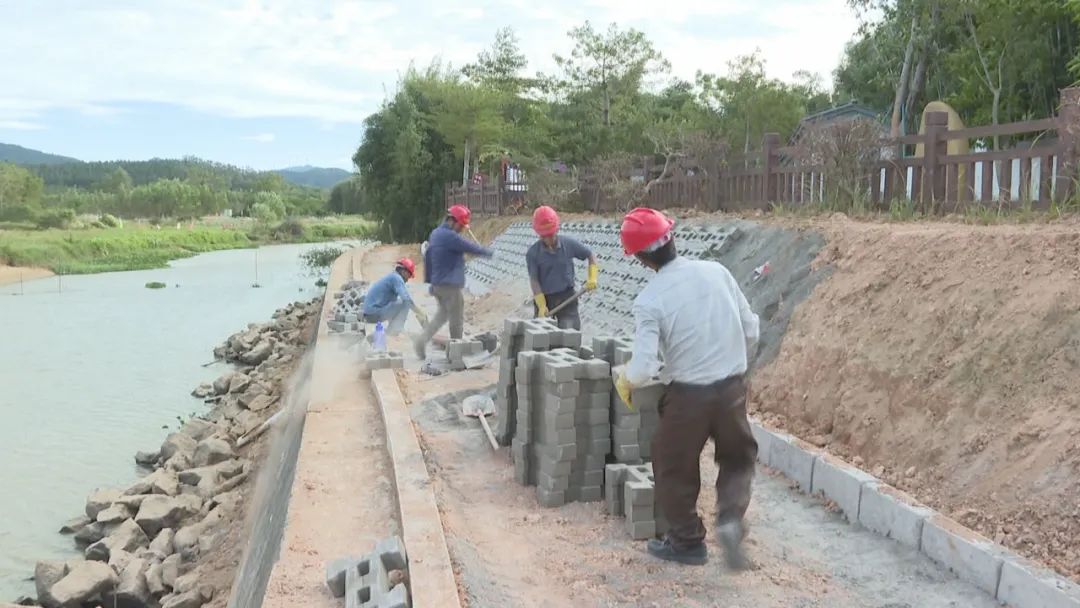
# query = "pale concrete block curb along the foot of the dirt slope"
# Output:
<box><xmin>751</xmin><ymin>420</ymin><xmax>1080</xmax><ymax>608</ymax></box>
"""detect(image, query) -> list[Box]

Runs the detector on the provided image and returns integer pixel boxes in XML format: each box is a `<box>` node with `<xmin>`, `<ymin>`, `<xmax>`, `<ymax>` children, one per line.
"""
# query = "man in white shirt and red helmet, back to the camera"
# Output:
<box><xmin>616</xmin><ymin>208</ymin><xmax>758</xmax><ymax>569</ymax></box>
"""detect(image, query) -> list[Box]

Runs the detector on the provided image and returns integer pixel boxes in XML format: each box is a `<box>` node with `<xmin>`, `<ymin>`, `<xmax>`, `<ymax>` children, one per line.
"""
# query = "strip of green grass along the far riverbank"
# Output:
<box><xmin>0</xmin><ymin>218</ymin><xmax>376</xmax><ymax>274</ymax></box>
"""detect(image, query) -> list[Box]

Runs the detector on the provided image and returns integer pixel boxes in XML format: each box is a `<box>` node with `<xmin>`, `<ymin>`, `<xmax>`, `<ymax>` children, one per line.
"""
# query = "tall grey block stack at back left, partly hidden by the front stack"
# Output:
<box><xmin>495</xmin><ymin>319</ymin><xmax>581</xmax><ymax>445</ymax></box>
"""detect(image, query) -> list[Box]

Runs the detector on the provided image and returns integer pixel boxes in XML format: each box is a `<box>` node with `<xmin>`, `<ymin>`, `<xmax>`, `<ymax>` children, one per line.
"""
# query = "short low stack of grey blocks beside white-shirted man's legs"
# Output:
<box><xmin>604</xmin><ymin>463</ymin><xmax>667</xmax><ymax>540</ymax></box>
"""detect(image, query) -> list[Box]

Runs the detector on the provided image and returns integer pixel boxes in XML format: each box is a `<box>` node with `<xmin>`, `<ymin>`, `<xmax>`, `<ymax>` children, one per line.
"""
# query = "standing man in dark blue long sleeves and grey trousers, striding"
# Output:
<box><xmin>414</xmin><ymin>205</ymin><xmax>495</xmax><ymax>360</ymax></box>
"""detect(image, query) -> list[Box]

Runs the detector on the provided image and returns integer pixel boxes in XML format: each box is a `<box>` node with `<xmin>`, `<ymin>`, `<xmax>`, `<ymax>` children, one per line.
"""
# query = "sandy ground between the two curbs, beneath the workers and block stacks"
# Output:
<box><xmin>343</xmin><ymin>240</ymin><xmax>994</xmax><ymax>607</ymax></box>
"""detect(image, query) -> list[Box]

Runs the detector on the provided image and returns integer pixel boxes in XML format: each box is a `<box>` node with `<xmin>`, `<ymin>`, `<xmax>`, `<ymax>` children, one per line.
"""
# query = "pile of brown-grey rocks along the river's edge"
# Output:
<box><xmin>27</xmin><ymin>300</ymin><xmax>321</xmax><ymax>608</ymax></box>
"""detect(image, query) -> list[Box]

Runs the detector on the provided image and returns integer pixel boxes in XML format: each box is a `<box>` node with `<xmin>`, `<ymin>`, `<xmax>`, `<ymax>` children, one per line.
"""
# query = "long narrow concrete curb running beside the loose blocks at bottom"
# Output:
<box><xmin>372</xmin><ymin>369</ymin><xmax>461</xmax><ymax>608</ymax></box>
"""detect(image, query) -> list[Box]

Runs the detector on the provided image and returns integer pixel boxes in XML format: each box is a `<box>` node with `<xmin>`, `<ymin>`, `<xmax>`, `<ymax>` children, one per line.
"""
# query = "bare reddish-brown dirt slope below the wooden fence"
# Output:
<box><xmin>753</xmin><ymin>218</ymin><xmax>1080</xmax><ymax>577</ymax></box>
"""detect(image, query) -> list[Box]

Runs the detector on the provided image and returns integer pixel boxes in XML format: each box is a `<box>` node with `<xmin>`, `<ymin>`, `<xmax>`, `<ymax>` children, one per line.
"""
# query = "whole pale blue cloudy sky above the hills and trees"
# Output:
<box><xmin>0</xmin><ymin>0</ymin><xmax>858</xmax><ymax>170</ymax></box>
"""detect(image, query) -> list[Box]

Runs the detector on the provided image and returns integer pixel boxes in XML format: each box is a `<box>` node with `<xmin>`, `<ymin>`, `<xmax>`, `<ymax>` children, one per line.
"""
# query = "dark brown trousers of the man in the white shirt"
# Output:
<box><xmin>652</xmin><ymin>376</ymin><xmax>757</xmax><ymax>549</ymax></box>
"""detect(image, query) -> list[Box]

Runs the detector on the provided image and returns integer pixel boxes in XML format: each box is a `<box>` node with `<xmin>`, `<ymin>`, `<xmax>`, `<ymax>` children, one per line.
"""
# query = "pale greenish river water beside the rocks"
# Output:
<box><xmin>0</xmin><ymin>245</ymin><xmax>345</xmax><ymax>603</ymax></box>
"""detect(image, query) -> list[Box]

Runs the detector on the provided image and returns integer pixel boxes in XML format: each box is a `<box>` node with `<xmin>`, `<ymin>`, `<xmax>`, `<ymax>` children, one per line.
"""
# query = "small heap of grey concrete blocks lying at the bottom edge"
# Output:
<box><xmin>326</xmin><ymin>537</ymin><xmax>409</xmax><ymax>608</ymax></box>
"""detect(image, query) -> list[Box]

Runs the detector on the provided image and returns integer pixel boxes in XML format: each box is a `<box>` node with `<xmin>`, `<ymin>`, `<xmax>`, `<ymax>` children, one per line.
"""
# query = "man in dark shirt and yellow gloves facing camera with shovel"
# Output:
<box><xmin>525</xmin><ymin>205</ymin><xmax>599</xmax><ymax>330</ymax></box>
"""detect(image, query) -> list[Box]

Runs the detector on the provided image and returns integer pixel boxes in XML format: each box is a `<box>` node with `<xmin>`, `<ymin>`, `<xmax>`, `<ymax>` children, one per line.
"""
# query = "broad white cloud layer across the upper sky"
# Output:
<box><xmin>0</xmin><ymin>0</ymin><xmax>856</xmax><ymax>129</ymax></box>
